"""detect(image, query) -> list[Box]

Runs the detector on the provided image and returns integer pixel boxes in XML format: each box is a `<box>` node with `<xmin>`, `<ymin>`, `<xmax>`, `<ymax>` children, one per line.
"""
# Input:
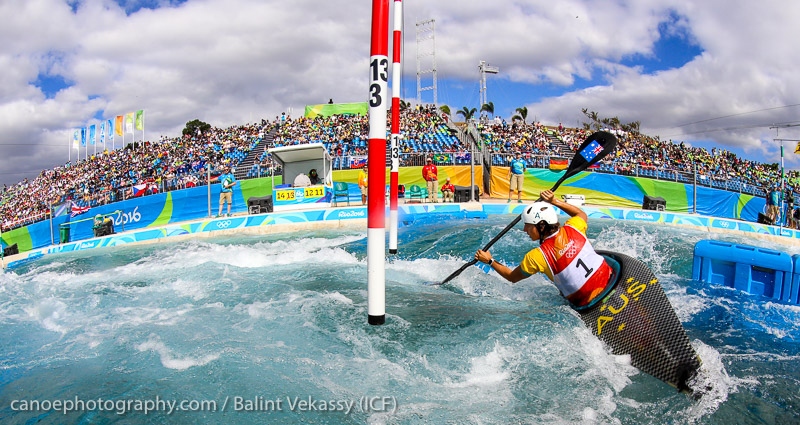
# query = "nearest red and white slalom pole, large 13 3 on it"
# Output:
<box><xmin>367</xmin><ymin>0</ymin><xmax>389</xmax><ymax>325</ymax></box>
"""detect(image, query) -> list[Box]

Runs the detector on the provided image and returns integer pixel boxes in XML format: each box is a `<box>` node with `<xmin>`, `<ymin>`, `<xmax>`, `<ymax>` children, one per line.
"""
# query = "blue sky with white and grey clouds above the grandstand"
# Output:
<box><xmin>0</xmin><ymin>0</ymin><xmax>800</xmax><ymax>184</ymax></box>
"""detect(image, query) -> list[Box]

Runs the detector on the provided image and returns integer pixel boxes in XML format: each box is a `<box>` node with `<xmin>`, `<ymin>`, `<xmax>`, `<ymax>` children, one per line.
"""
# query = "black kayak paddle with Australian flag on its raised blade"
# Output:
<box><xmin>434</xmin><ymin>131</ymin><xmax>617</xmax><ymax>285</ymax></box>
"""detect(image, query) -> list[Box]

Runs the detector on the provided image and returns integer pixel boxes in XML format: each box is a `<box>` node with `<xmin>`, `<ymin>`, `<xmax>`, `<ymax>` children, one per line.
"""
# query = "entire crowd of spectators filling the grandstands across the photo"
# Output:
<box><xmin>0</xmin><ymin>105</ymin><xmax>800</xmax><ymax>231</ymax></box>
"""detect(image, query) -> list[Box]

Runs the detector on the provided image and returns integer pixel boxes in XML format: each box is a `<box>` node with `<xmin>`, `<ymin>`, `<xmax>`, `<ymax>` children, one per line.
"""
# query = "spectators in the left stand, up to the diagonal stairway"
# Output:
<box><xmin>0</xmin><ymin>121</ymin><xmax>265</xmax><ymax>231</ymax></box>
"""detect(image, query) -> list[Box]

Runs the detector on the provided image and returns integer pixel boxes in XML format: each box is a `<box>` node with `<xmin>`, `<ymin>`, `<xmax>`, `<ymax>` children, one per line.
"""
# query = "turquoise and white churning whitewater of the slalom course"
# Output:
<box><xmin>0</xmin><ymin>216</ymin><xmax>800</xmax><ymax>425</ymax></box>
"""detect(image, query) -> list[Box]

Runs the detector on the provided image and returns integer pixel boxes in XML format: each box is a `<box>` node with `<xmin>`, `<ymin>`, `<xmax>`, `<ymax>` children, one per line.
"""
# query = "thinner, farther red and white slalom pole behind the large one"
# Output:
<box><xmin>389</xmin><ymin>0</ymin><xmax>403</xmax><ymax>254</ymax></box>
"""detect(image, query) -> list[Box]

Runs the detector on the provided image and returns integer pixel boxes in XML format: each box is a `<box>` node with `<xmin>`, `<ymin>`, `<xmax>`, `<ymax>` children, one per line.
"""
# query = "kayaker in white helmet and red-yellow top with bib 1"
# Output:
<box><xmin>475</xmin><ymin>190</ymin><xmax>616</xmax><ymax>308</ymax></box>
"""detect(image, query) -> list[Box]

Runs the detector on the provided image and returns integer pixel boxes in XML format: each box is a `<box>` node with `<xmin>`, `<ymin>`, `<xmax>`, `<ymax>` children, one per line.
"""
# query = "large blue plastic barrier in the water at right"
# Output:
<box><xmin>692</xmin><ymin>240</ymin><xmax>800</xmax><ymax>304</ymax></box>
